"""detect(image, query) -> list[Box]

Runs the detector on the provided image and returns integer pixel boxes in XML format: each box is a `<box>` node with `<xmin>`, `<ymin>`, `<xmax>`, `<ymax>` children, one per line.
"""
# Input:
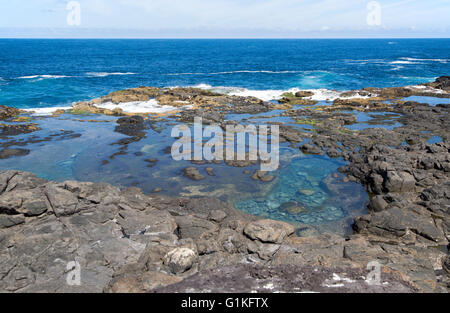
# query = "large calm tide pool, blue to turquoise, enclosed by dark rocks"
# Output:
<box><xmin>0</xmin><ymin>112</ymin><xmax>368</xmax><ymax>234</ymax></box>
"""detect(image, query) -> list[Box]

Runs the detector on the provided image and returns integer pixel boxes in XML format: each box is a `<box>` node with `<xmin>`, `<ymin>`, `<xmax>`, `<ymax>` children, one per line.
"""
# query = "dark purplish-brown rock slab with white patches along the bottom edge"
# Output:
<box><xmin>155</xmin><ymin>265</ymin><xmax>418</xmax><ymax>293</ymax></box>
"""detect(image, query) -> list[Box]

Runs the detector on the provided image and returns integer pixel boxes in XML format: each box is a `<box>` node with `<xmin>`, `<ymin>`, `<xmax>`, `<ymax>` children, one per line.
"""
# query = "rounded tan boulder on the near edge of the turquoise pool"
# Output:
<box><xmin>244</xmin><ymin>220</ymin><xmax>295</xmax><ymax>243</ymax></box>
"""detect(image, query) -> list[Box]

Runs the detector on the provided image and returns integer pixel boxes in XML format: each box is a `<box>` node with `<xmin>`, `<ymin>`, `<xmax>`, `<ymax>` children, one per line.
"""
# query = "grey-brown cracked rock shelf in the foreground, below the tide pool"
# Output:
<box><xmin>0</xmin><ymin>171</ymin><xmax>448</xmax><ymax>292</ymax></box>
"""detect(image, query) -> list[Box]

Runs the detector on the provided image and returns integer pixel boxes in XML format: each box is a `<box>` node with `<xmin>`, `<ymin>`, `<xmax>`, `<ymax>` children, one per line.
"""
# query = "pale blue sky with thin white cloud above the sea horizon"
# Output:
<box><xmin>0</xmin><ymin>0</ymin><xmax>450</xmax><ymax>38</ymax></box>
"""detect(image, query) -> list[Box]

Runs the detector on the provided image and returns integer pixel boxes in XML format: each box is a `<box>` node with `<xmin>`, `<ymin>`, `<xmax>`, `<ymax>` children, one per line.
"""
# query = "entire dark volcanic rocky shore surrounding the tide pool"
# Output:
<box><xmin>0</xmin><ymin>77</ymin><xmax>450</xmax><ymax>292</ymax></box>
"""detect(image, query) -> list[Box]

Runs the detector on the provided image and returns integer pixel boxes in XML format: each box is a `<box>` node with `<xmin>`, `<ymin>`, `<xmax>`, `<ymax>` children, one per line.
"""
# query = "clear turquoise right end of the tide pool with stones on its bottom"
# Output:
<box><xmin>235</xmin><ymin>155</ymin><xmax>368</xmax><ymax>233</ymax></box>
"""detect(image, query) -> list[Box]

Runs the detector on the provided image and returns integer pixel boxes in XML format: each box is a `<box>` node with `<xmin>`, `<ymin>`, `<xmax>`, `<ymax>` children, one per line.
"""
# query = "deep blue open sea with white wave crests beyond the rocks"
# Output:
<box><xmin>0</xmin><ymin>39</ymin><xmax>450</xmax><ymax>108</ymax></box>
